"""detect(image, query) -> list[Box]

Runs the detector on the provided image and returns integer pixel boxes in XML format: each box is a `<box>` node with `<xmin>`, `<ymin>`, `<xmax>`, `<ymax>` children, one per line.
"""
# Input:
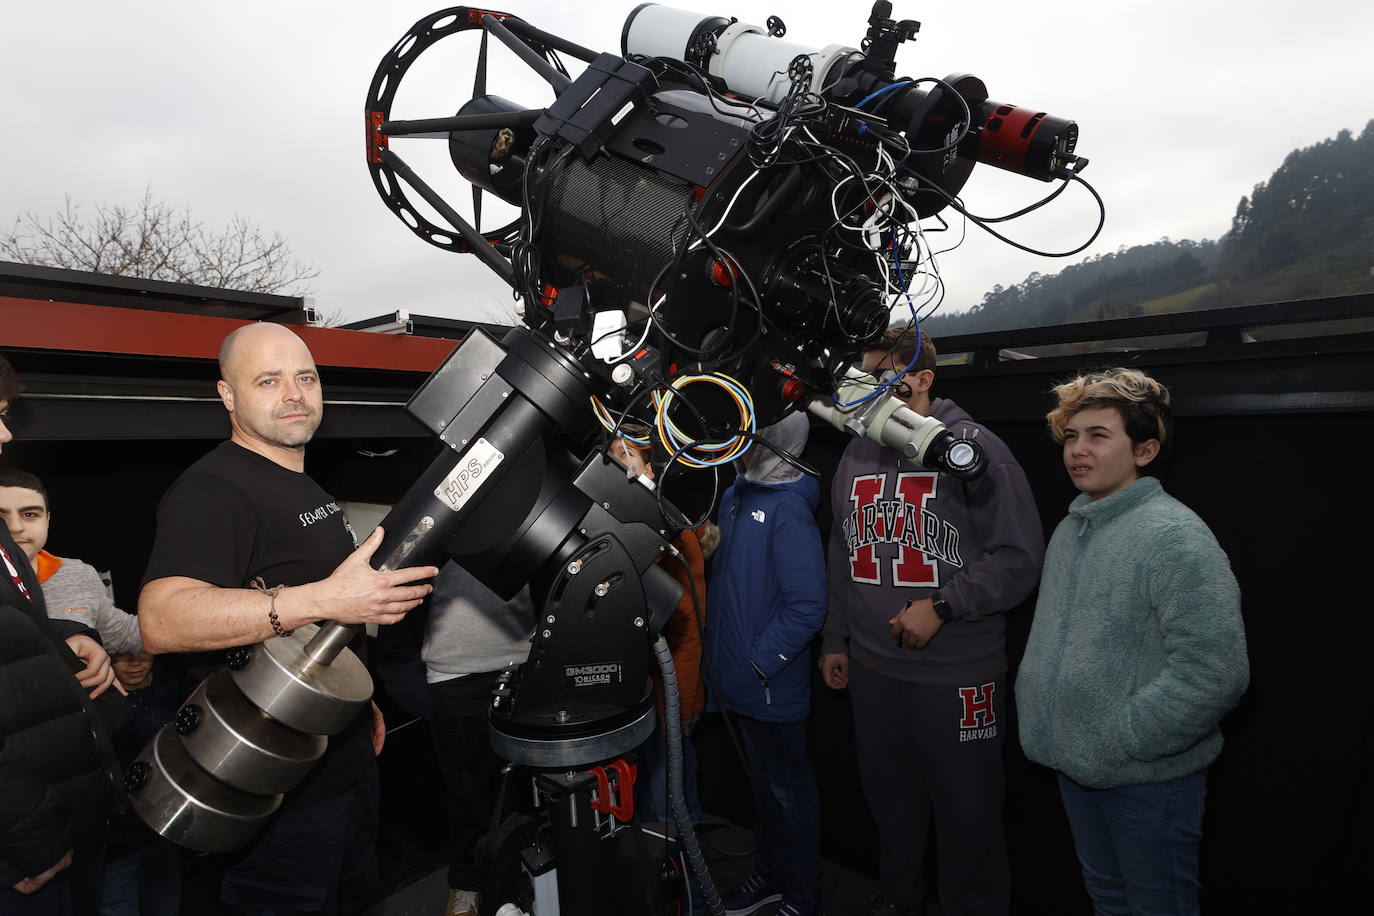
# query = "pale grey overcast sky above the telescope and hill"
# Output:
<box><xmin>0</xmin><ymin>0</ymin><xmax>1374</xmax><ymax>332</ymax></box>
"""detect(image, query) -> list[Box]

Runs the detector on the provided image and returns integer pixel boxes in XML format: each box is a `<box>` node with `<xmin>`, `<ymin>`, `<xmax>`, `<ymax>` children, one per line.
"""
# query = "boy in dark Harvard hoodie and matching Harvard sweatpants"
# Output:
<box><xmin>820</xmin><ymin>327</ymin><xmax>1044</xmax><ymax>916</ymax></box>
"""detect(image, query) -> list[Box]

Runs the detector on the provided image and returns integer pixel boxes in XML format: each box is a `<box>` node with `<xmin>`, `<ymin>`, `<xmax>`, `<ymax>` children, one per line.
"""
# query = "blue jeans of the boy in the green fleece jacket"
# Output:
<box><xmin>1059</xmin><ymin>769</ymin><xmax>1206</xmax><ymax>916</ymax></box>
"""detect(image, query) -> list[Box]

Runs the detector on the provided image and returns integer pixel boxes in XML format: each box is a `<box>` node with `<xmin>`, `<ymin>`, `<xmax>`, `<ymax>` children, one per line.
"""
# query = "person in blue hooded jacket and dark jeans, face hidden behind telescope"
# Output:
<box><xmin>706</xmin><ymin>412</ymin><xmax>826</xmax><ymax>916</ymax></box>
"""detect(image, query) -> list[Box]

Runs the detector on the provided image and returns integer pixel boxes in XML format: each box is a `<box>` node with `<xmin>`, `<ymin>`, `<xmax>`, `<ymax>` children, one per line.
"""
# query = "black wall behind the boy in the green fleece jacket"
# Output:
<box><xmin>785</xmin><ymin>357</ymin><xmax>1374</xmax><ymax>913</ymax></box>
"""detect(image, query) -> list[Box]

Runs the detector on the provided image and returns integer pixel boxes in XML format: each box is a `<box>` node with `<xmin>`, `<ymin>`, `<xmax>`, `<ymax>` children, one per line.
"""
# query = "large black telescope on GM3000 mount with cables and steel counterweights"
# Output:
<box><xmin>131</xmin><ymin>1</ymin><xmax>1087</xmax><ymax>913</ymax></box>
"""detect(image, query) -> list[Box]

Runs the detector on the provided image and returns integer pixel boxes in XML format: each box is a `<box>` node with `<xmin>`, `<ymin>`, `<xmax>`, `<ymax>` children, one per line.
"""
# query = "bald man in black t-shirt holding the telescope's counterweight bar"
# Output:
<box><xmin>139</xmin><ymin>324</ymin><xmax>438</xmax><ymax>915</ymax></box>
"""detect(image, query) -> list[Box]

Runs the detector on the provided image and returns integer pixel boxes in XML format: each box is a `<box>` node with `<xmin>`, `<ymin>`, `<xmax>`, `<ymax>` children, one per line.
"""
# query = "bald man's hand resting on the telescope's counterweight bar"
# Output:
<box><xmin>298</xmin><ymin>527</ymin><xmax>438</xmax><ymax>623</ymax></box>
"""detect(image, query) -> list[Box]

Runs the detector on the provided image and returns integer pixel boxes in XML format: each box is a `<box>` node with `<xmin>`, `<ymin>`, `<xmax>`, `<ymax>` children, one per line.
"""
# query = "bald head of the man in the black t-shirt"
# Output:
<box><xmin>220</xmin><ymin>325</ymin><xmax>324</xmax><ymax>448</ymax></box>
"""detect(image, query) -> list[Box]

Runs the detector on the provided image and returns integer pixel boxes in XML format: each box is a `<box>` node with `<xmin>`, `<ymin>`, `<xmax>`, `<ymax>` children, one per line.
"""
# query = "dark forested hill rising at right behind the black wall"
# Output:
<box><xmin>925</xmin><ymin>121</ymin><xmax>1374</xmax><ymax>336</ymax></box>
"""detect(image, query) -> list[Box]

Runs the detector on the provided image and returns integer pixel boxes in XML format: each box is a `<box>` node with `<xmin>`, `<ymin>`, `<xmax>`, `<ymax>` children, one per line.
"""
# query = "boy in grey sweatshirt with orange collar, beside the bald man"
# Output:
<box><xmin>0</xmin><ymin>467</ymin><xmax>143</xmax><ymax>655</ymax></box>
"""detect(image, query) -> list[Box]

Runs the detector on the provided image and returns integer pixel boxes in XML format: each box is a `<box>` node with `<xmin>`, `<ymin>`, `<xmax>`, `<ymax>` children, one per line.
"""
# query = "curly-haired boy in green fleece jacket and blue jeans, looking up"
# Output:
<box><xmin>1015</xmin><ymin>369</ymin><xmax>1249</xmax><ymax>915</ymax></box>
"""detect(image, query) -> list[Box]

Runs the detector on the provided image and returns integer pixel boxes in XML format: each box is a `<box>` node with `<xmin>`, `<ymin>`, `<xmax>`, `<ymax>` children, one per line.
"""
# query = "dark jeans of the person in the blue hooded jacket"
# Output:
<box><xmin>734</xmin><ymin>715</ymin><xmax>820</xmax><ymax>894</ymax></box>
